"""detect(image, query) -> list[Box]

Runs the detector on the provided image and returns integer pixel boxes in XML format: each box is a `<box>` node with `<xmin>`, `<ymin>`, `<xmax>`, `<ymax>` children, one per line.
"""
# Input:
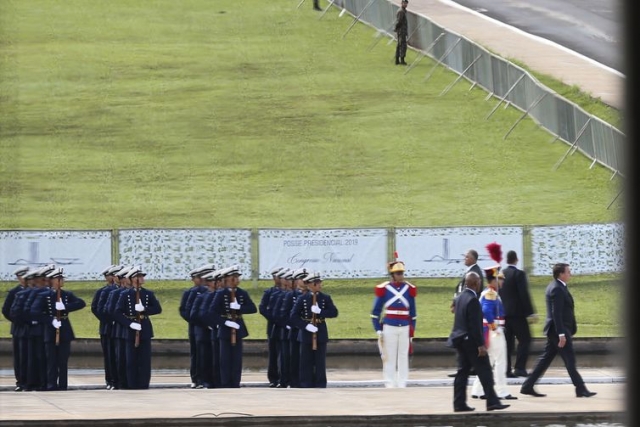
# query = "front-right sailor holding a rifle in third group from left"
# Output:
<box><xmin>212</xmin><ymin>265</ymin><xmax>258</xmax><ymax>388</ymax></box>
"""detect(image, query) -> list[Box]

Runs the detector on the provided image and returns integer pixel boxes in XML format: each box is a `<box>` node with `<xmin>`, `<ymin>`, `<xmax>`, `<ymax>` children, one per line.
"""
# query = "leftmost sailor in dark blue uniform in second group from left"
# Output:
<box><xmin>91</xmin><ymin>265</ymin><xmax>122</xmax><ymax>390</ymax></box>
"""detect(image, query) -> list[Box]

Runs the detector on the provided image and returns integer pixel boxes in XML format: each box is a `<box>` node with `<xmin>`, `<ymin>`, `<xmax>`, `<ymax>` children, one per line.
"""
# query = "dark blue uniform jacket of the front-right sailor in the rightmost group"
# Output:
<box><xmin>289</xmin><ymin>292</ymin><xmax>338</xmax><ymax>343</ymax></box>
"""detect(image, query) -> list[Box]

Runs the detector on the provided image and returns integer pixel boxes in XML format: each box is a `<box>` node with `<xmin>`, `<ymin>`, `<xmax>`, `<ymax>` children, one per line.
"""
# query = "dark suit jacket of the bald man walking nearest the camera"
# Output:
<box><xmin>447</xmin><ymin>289</ymin><xmax>484</xmax><ymax>347</ymax></box>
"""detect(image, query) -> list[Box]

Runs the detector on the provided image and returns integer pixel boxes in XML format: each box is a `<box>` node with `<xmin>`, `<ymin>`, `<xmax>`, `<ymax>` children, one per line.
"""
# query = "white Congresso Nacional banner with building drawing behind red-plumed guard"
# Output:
<box><xmin>396</xmin><ymin>227</ymin><xmax>523</xmax><ymax>277</ymax></box>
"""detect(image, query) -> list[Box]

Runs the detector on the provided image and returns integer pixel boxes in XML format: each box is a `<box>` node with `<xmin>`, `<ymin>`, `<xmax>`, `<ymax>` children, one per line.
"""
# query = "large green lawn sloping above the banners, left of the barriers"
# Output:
<box><xmin>0</xmin><ymin>0</ymin><xmax>623</xmax><ymax>229</ymax></box>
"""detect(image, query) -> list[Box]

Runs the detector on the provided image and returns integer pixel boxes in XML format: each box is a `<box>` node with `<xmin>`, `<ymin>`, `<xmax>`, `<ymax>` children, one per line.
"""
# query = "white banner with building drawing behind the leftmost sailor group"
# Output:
<box><xmin>0</xmin><ymin>231</ymin><xmax>111</xmax><ymax>281</ymax></box>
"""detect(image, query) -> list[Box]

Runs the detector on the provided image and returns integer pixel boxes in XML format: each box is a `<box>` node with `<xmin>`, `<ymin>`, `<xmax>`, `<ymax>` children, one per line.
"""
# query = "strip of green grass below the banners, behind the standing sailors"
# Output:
<box><xmin>0</xmin><ymin>275</ymin><xmax>622</xmax><ymax>339</ymax></box>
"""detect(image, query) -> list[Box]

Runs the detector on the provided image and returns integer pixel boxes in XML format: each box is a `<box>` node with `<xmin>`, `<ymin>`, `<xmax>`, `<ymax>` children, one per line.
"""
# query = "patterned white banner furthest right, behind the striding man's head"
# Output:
<box><xmin>531</xmin><ymin>223</ymin><xmax>624</xmax><ymax>276</ymax></box>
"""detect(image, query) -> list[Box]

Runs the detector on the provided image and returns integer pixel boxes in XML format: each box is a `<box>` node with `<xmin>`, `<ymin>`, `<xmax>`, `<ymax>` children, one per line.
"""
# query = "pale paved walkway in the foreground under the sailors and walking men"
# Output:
<box><xmin>0</xmin><ymin>368</ymin><xmax>625</xmax><ymax>425</ymax></box>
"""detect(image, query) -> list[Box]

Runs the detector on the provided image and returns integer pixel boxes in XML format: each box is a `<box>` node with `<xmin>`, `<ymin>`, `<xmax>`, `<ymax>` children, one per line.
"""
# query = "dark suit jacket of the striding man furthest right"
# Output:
<box><xmin>544</xmin><ymin>280</ymin><xmax>578</xmax><ymax>336</ymax></box>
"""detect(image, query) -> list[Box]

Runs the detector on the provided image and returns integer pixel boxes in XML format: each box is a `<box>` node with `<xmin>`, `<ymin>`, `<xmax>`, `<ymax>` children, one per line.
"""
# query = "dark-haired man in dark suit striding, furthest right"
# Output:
<box><xmin>520</xmin><ymin>263</ymin><xmax>596</xmax><ymax>397</ymax></box>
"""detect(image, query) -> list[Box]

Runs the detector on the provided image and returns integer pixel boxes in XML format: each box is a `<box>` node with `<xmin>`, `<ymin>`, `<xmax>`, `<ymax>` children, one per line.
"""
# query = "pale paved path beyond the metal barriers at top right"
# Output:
<box><xmin>393</xmin><ymin>0</ymin><xmax>625</xmax><ymax>110</ymax></box>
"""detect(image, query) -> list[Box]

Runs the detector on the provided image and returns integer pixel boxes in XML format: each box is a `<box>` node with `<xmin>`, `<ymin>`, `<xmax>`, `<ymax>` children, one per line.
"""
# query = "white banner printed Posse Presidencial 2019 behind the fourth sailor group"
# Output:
<box><xmin>258</xmin><ymin>228</ymin><xmax>387</xmax><ymax>279</ymax></box>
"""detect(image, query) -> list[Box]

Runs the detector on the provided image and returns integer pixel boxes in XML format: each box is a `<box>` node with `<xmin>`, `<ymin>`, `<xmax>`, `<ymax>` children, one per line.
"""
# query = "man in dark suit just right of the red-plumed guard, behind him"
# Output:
<box><xmin>499</xmin><ymin>251</ymin><xmax>538</xmax><ymax>378</ymax></box>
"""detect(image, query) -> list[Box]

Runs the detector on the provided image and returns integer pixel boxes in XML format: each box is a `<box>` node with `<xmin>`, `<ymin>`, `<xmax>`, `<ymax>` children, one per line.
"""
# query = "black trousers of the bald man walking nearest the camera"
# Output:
<box><xmin>453</xmin><ymin>339</ymin><xmax>500</xmax><ymax>409</ymax></box>
